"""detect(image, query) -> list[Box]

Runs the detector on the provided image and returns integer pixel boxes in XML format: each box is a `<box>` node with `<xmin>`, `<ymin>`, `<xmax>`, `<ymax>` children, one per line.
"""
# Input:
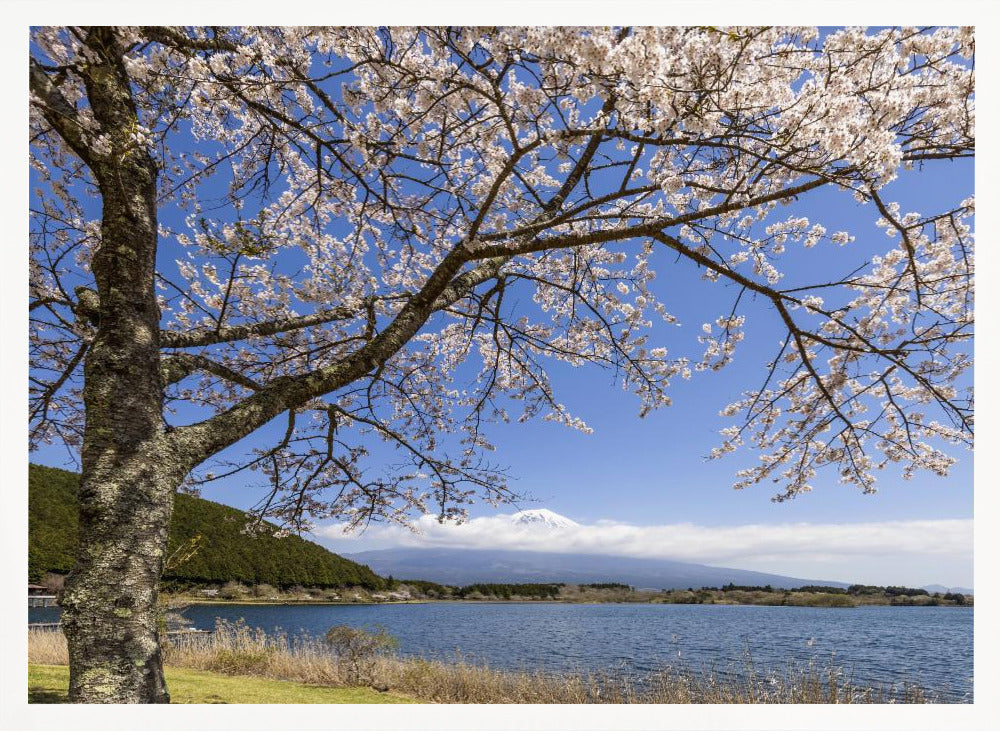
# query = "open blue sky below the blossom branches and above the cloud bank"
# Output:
<box><xmin>32</xmin><ymin>30</ymin><xmax>973</xmax><ymax>586</ymax></box>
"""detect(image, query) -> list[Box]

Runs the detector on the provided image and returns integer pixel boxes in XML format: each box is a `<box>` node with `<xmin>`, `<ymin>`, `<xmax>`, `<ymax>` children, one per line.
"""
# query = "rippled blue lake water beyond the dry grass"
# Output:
<box><xmin>29</xmin><ymin>602</ymin><xmax>973</xmax><ymax>701</ymax></box>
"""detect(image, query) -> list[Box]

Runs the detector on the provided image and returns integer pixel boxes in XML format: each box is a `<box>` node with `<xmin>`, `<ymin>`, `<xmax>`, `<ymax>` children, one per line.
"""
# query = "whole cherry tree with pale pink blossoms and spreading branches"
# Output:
<box><xmin>30</xmin><ymin>27</ymin><xmax>975</xmax><ymax>702</ymax></box>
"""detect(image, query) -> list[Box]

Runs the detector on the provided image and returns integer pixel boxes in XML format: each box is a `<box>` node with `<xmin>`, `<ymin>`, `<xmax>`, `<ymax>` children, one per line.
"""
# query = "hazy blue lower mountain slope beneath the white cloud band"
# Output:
<box><xmin>346</xmin><ymin>548</ymin><xmax>848</xmax><ymax>589</ymax></box>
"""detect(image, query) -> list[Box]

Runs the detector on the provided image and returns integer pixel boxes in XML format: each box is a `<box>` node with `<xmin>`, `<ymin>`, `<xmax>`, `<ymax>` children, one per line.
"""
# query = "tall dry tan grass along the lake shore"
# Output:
<box><xmin>28</xmin><ymin>623</ymin><xmax>939</xmax><ymax>703</ymax></box>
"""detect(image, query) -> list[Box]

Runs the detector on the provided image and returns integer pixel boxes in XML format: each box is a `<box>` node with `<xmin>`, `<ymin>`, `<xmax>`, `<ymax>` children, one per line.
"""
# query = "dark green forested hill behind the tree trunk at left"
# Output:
<box><xmin>28</xmin><ymin>465</ymin><xmax>386</xmax><ymax>589</ymax></box>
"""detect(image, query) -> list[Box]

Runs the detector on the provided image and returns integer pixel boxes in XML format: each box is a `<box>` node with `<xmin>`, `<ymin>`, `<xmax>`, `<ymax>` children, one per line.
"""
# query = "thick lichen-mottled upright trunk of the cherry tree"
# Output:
<box><xmin>62</xmin><ymin>28</ymin><xmax>175</xmax><ymax>703</ymax></box>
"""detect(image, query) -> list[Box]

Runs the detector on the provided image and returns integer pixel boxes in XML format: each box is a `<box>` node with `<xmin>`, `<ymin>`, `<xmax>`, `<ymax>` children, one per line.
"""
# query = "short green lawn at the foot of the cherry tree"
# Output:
<box><xmin>28</xmin><ymin>665</ymin><xmax>417</xmax><ymax>703</ymax></box>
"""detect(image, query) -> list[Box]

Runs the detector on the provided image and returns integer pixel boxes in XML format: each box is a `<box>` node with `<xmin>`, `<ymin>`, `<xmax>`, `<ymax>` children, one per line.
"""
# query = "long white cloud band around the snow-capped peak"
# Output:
<box><xmin>316</xmin><ymin>511</ymin><xmax>973</xmax><ymax>586</ymax></box>
